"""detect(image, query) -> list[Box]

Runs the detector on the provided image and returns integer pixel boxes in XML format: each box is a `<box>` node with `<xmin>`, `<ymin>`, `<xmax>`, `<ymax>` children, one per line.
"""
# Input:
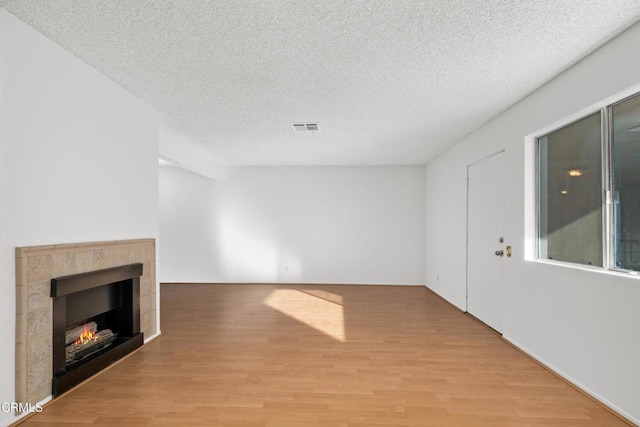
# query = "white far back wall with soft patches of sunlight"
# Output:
<box><xmin>160</xmin><ymin>167</ymin><xmax>424</xmax><ymax>284</ymax></box>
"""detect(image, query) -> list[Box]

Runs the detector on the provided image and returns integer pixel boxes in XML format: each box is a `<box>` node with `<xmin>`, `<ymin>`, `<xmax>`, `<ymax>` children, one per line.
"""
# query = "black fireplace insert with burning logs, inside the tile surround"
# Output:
<box><xmin>51</xmin><ymin>263</ymin><xmax>143</xmax><ymax>397</ymax></box>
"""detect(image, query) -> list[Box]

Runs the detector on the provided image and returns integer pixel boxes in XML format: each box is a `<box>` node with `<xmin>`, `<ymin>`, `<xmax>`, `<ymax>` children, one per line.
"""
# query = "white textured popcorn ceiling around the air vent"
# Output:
<box><xmin>0</xmin><ymin>0</ymin><xmax>640</xmax><ymax>165</ymax></box>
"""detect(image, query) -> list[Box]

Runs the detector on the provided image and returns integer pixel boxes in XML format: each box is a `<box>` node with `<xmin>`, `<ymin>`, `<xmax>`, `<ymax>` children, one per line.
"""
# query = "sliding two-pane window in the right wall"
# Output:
<box><xmin>537</xmin><ymin>94</ymin><xmax>640</xmax><ymax>271</ymax></box>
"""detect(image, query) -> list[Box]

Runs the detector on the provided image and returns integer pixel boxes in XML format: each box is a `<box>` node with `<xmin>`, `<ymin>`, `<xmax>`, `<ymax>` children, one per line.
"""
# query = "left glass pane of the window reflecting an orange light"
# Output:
<box><xmin>538</xmin><ymin>112</ymin><xmax>603</xmax><ymax>266</ymax></box>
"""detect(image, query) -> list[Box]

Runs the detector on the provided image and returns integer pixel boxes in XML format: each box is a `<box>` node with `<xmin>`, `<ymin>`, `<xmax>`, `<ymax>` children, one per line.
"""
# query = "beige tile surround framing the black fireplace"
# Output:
<box><xmin>15</xmin><ymin>239</ymin><xmax>157</xmax><ymax>404</ymax></box>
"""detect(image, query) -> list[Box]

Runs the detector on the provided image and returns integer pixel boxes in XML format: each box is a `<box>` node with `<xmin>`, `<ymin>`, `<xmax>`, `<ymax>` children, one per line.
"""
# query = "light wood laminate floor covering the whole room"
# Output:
<box><xmin>17</xmin><ymin>284</ymin><xmax>626</xmax><ymax>427</ymax></box>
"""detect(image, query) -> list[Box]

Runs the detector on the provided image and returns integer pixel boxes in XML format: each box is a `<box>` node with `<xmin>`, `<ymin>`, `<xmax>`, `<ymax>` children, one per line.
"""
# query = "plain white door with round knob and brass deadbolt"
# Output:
<box><xmin>467</xmin><ymin>152</ymin><xmax>505</xmax><ymax>332</ymax></box>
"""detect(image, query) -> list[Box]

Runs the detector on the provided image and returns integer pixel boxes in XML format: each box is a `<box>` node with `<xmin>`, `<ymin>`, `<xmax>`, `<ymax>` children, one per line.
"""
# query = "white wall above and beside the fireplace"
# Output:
<box><xmin>0</xmin><ymin>10</ymin><xmax>158</xmax><ymax>425</ymax></box>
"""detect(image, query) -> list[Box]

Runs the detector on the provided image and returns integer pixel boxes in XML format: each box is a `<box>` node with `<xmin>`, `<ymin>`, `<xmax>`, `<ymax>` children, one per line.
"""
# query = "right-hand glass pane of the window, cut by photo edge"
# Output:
<box><xmin>611</xmin><ymin>95</ymin><xmax>640</xmax><ymax>270</ymax></box>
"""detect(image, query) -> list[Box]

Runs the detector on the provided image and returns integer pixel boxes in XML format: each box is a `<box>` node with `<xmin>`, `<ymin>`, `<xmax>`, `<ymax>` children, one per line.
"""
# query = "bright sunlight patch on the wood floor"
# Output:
<box><xmin>264</xmin><ymin>289</ymin><xmax>345</xmax><ymax>342</ymax></box>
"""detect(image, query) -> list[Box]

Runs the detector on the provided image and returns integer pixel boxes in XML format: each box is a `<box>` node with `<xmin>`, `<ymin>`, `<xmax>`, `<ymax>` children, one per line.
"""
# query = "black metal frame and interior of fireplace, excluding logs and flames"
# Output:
<box><xmin>51</xmin><ymin>263</ymin><xmax>144</xmax><ymax>397</ymax></box>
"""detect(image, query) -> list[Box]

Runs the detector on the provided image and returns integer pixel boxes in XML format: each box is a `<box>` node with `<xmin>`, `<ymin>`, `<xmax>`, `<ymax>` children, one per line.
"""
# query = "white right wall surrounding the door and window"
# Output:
<box><xmin>425</xmin><ymin>20</ymin><xmax>640</xmax><ymax>423</ymax></box>
